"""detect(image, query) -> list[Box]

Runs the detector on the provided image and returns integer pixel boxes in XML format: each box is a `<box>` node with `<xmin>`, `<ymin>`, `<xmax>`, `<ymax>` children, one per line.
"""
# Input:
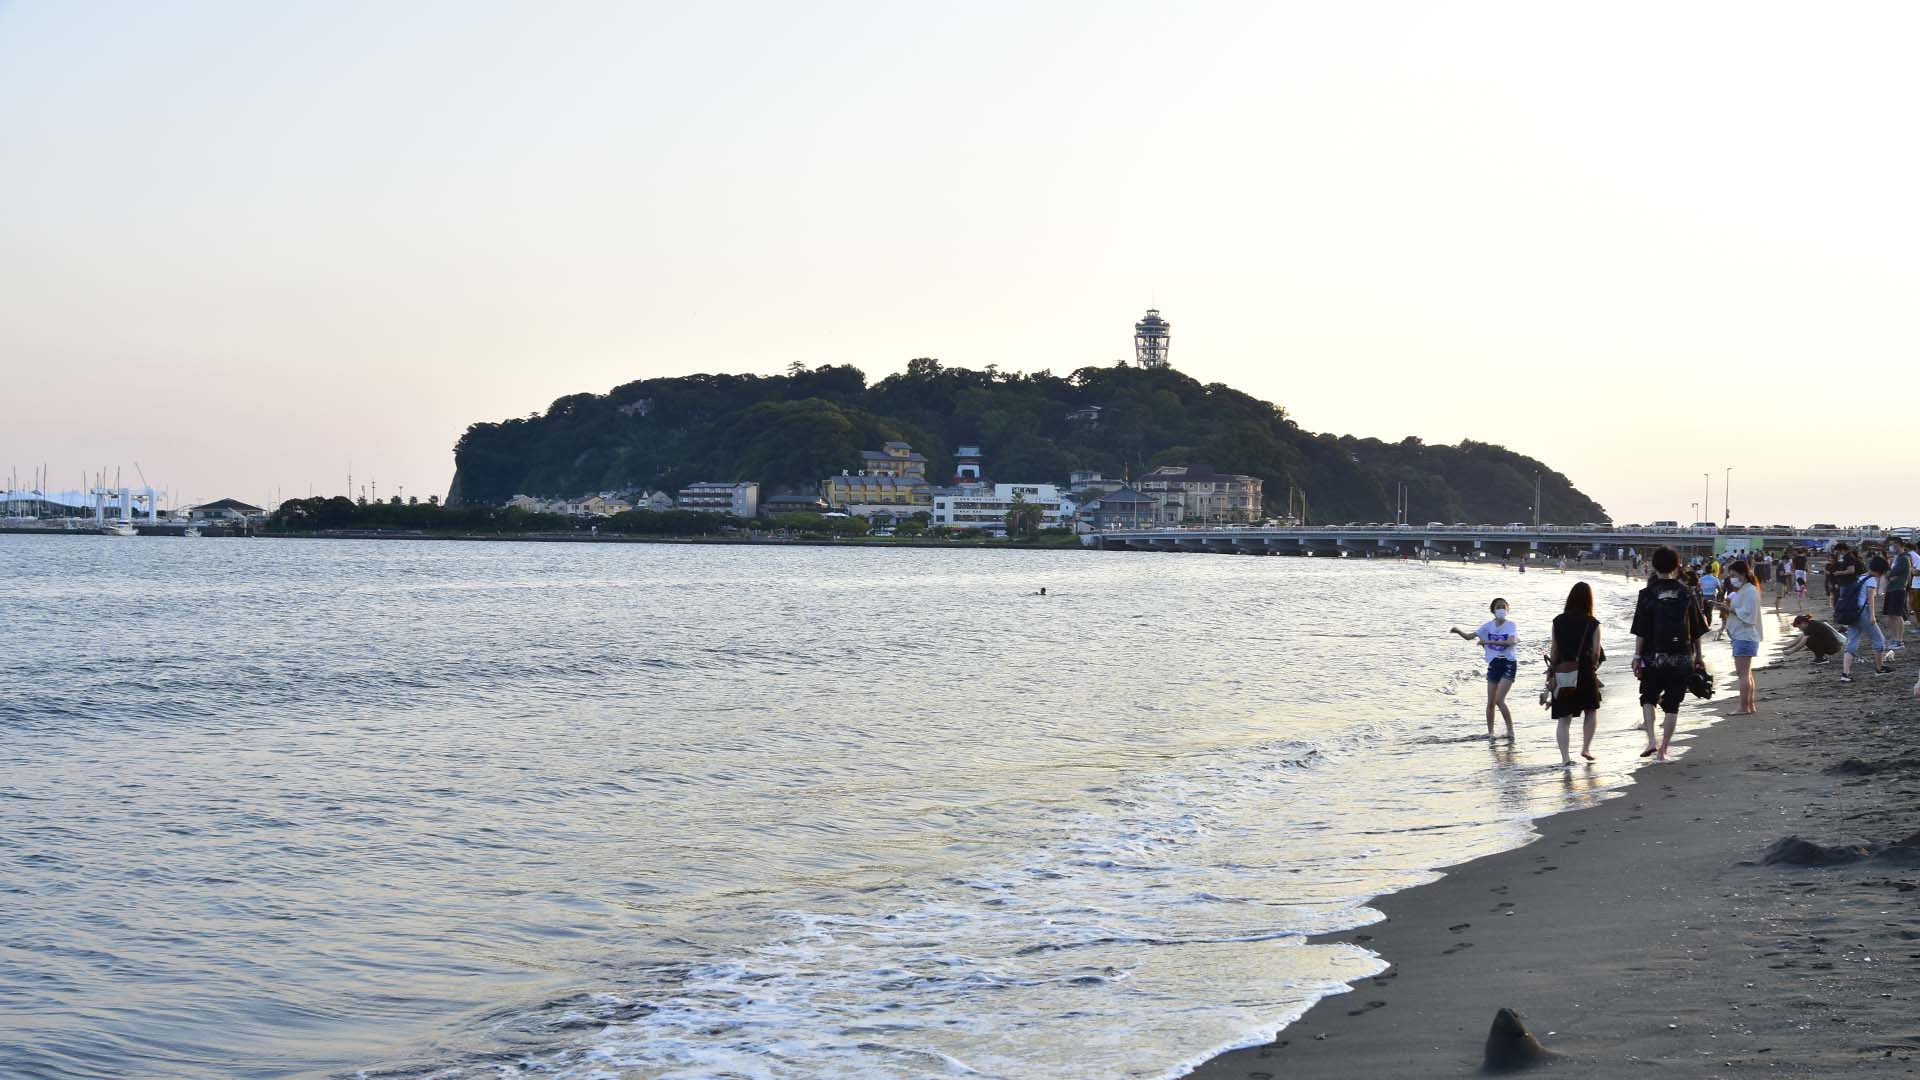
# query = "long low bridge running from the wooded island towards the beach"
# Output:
<box><xmin>1081</xmin><ymin>525</ymin><xmax>1884</xmax><ymax>559</ymax></box>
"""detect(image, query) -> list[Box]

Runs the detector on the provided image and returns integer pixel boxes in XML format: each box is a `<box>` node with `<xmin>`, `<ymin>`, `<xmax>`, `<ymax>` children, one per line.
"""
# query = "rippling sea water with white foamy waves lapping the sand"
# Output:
<box><xmin>0</xmin><ymin>536</ymin><xmax>1704</xmax><ymax>1080</ymax></box>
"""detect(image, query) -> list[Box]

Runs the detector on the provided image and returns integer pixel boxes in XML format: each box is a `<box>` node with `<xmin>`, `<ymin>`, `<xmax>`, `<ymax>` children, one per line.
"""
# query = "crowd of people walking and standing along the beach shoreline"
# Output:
<box><xmin>1452</xmin><ymin>538</ymin><xmax>1920</xmax><ymax>769</ymax></box>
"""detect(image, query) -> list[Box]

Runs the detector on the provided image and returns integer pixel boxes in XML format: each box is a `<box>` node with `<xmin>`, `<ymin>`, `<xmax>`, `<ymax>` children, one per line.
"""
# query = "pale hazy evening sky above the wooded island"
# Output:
<box><xmin>0</xmin><ymin>0</ymin><xmax>1920</xmax><ymax>525</ymax></box>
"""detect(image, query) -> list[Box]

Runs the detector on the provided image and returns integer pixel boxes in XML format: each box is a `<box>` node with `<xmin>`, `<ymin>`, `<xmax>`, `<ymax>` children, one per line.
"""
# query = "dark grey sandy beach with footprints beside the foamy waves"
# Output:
<box><xmin>1190</xmin><ymin>641</ymin><xmax>1920</xmax><ymax>1080</ymax></box>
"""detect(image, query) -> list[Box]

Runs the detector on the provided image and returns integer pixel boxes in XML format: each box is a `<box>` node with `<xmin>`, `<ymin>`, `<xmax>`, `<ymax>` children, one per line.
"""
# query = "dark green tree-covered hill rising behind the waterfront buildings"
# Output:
<box><xmin>449</xmin><ymin>359</ymin><xmax>1607</xmax><ymax>525</ymax></box>
